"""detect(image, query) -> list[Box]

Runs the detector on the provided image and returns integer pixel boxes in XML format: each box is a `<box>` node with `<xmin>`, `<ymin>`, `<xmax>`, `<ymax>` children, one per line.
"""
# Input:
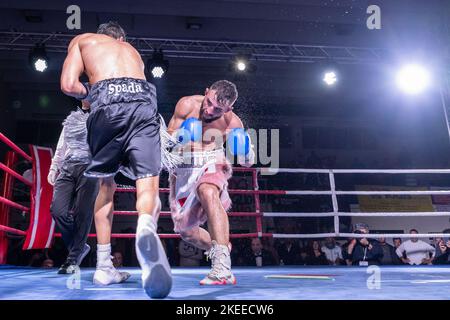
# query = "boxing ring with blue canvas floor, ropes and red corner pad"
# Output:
<box><xmin>0</xmin><ymin>134</ymin><xmax>450</xmax><ymax>301</ymax></box>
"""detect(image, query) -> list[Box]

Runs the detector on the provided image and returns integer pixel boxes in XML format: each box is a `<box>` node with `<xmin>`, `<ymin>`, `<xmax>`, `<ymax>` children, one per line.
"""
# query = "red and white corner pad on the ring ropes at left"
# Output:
<box><xmin>23</xmin><ymin>146</ymin><xmax>55</xmax><ymax>250</ymax></box>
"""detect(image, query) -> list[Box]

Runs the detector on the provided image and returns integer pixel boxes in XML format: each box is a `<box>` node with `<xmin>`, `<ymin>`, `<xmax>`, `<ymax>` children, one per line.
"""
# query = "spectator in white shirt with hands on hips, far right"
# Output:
<box><xmin>395</xmin><ymin>229</ymin><xmax>436</xmax><ymax>265</ymax></box>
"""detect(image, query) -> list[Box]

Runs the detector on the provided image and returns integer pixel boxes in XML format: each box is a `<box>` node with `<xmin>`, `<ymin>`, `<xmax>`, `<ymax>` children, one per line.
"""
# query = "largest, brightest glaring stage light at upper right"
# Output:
<box><xmin>396</xmin><ymin>64</ymin><xmax>430</xmax><ymax>94</ymax></box>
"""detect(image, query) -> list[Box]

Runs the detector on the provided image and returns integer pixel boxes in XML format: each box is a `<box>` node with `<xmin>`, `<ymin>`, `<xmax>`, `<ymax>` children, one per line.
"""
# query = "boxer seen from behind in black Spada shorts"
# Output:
<box><xmin>61</xmin><ymin>22</ymin><xmax>172</xmax><ymax>298</ymax></box>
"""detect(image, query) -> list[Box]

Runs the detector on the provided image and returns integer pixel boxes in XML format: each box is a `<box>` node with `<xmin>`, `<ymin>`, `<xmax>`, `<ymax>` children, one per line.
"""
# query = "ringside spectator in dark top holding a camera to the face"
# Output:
<box><xmin>347</xmin><ymin>223</ymin><xmax>383</xmax><ymax>266</ymax></box>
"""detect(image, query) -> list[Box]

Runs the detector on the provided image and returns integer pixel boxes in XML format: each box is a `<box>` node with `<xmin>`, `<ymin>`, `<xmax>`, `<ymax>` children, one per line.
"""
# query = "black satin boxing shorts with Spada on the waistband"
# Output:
<box><xmin>84</xmin><ymin>78</ymin><xmax>161</xmax><ymax>180</ymax></box>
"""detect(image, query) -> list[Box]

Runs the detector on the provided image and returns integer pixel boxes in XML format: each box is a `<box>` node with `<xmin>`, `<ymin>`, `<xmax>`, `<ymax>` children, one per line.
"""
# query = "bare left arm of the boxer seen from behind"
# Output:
<box><xmin>60</xmin><ymin>34</ymin><xmax>87</xmax><ymax>99</ymax></box>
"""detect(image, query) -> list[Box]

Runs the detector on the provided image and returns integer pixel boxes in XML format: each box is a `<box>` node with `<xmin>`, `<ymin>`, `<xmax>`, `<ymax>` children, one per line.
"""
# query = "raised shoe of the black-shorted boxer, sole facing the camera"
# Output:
<box><xmin>136</xmin><ymin>223</ymin><xmax>172</xmax><ymax>298</ymax></box>
